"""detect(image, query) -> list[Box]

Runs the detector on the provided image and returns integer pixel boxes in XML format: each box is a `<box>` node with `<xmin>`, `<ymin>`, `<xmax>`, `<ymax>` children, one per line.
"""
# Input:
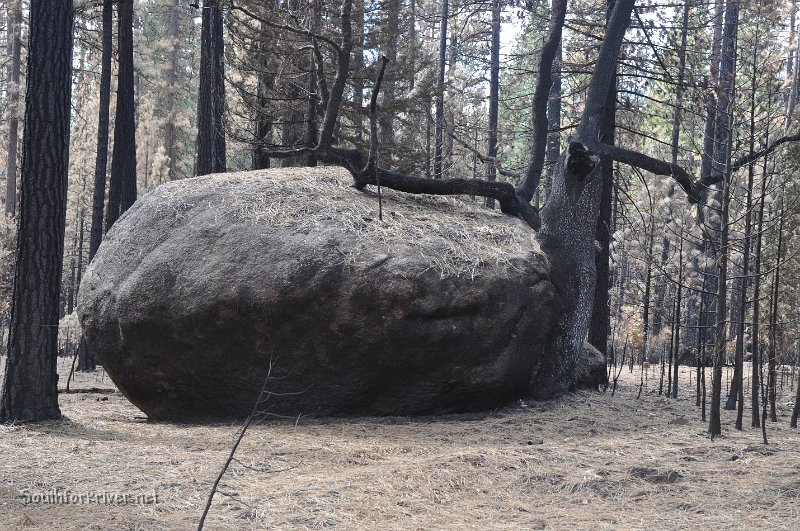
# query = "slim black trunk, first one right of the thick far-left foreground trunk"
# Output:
<box><xmin>89</xmin><ymin>0</ymin><xmax>114</xmax><ymax>261</ymax></box>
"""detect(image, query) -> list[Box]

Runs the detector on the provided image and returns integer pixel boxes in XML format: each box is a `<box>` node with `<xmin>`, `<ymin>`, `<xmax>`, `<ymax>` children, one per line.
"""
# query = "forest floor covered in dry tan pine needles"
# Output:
<box><xmin>0</xmin><ymin>360</ymin><xmax>800</xmax><ymax>530</ymax></box>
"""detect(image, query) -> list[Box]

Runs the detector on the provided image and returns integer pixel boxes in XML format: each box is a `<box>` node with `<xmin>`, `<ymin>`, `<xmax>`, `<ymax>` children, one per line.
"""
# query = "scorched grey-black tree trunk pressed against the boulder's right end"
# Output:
<box><xmin>530</xmin><ymin>0</ymin><xmax>634</xmax><ymax>397</ymax></box>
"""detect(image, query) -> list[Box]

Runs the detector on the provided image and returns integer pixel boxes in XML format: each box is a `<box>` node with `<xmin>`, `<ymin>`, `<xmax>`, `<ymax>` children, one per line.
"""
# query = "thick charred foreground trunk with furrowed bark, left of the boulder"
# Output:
<box><xmin>0</xmin><ymin>0</ymin><xmax>74</xmax><ymax>423</ymax></box>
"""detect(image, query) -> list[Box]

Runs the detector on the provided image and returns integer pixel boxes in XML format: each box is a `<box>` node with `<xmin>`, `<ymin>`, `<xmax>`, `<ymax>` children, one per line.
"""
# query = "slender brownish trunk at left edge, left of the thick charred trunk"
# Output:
<box><xmin>6</xmin><ymin>0</ymin><xmax>22</xmax><ymax>217</ymax></box>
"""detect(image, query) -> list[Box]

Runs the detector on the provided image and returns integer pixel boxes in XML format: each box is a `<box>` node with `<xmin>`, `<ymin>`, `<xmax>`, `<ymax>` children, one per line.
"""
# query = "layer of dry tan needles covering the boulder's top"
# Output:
<box><xmin>148</xmin><ymin>167</ymin><xmax>539</xmax><ymax>277</ymax></box>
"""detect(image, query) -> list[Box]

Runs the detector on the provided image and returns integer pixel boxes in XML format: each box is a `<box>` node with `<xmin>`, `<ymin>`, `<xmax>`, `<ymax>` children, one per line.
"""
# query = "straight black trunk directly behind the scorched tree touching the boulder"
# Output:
<box><xmin>589</xmin><ymin>0</ymin><xmax>617</xmax><ymax>362</ymax></box>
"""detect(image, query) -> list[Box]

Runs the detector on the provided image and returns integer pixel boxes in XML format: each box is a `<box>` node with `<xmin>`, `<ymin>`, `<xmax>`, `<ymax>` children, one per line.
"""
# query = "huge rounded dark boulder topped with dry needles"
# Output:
<box><xmin>78</xmin><ymin>168</ymin><xmax>554</xmax><ymax>421</ymax></box>
